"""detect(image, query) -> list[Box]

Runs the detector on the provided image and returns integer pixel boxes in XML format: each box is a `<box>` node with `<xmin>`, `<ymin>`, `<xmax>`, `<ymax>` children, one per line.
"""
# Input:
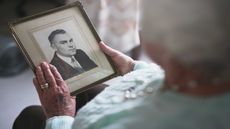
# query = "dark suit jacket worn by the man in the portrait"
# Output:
<box><xmin>50</xmin><ymin>49</ymin><xmax>97</xmax><ymax>80</ymax></box>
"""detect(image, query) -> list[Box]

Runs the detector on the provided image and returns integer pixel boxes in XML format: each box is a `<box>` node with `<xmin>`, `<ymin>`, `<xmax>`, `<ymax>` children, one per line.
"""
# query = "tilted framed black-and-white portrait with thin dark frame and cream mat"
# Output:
<box><xmin>9</xmin><ymin>2</ymin><xmax>117</xmax><ymax>94</ymax></box>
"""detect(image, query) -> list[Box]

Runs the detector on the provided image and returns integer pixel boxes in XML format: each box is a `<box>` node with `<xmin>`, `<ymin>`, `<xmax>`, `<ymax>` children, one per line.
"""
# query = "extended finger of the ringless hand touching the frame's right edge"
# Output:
<box><xmin>99</xmin><ymin>42</ymin><xmax>120</xmax><ymax>57</ymax></box>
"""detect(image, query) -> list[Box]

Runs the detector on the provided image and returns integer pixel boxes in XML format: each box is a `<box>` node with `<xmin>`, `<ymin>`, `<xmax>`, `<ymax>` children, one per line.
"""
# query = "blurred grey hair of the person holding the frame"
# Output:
<box><xmin>142</xmin><ymin>0</ymin><xmax>230</xmax><ymax>80</ymax></box>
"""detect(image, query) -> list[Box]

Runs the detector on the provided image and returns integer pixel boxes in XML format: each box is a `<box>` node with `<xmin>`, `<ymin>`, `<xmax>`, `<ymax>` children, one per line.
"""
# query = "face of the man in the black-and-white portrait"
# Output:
<box><xmin>52</xmin><ymin>33</ymin><xmax>76</xmax><ymax>57</ymax></box>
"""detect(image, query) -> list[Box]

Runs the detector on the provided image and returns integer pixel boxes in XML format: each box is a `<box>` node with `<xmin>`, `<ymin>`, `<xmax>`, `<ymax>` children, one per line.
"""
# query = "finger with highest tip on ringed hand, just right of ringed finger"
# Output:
<box><xmin>41</xmin><ymin>62</ymin><xmax>56</xmax><ymax>87</ymax></box>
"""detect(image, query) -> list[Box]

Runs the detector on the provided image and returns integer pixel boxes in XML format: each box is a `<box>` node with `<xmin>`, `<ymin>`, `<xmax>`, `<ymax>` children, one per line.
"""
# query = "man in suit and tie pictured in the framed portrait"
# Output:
<box><xmin>48</xmin><ymin>29</ymin><xmax>97</xmax><ymax>80</ymax></box>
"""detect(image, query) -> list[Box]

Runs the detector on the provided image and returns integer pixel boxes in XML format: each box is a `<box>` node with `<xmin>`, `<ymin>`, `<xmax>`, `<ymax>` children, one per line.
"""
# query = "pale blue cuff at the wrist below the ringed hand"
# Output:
<box><xmin>45</xmin><ymin>116</ymin><xmax>74</xmax><ymax>129</ymax></box>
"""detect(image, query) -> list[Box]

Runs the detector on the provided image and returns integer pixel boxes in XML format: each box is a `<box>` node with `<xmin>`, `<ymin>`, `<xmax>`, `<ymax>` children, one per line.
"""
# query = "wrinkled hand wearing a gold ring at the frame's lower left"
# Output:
<box><xmin>33</xmin><ymin>62</ymin><xmax>76</xmax><ymax>118</ymax></box>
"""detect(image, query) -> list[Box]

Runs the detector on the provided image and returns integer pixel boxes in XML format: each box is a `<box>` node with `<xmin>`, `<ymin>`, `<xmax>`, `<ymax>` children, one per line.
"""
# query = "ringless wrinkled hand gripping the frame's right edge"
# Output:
<box><xmin>99</xmin><ymin>42</ymin><xmax>135</xmax><ymax>75</ymax></box>
